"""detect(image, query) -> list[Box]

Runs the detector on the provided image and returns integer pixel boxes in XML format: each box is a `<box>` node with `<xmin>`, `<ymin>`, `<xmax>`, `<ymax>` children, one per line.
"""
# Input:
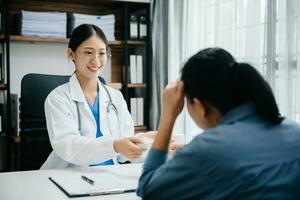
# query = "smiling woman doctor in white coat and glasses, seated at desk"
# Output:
<box><xmin>41</xmin><ymin>24</ymin><xmax>144</xmax><ymax>169</ymax></box>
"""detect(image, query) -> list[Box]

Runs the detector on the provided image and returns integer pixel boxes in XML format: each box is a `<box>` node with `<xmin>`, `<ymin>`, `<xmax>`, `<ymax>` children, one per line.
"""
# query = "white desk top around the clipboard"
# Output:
<box><xmin>0</xmin><ymin>164</ymin><xmax>142</xmax><ymax>200</ymax></box>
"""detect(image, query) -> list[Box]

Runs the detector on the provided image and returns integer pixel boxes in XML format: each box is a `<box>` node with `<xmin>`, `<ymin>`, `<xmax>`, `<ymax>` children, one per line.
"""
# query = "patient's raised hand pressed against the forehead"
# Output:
<box><xmin>161</xmin><ymin>80</ymin><xmax>184</xmax><ymax>119</ymax></box>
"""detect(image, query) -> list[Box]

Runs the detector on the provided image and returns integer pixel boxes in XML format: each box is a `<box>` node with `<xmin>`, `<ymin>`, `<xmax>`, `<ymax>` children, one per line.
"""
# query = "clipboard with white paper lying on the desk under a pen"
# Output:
<box><xmin>49</xmin><ymin>174</ymin><xmax>137</xmax><ymax>198</ymax></box>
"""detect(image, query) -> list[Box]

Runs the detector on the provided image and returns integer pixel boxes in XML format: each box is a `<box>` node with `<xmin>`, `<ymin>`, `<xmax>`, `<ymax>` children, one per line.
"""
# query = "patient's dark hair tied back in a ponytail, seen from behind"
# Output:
<box><xmin>181</xmin><ymin>48</ymin><xmax>283</xmax><ymax>124</ymax></box>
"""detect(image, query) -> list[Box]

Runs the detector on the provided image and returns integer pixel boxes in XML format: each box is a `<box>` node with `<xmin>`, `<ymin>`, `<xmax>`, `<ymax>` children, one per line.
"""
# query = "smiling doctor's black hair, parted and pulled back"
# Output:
<box><xmin>68</xmin><ymin>24</ymin><xmax>108</xmax><ymax>52</ymax></box>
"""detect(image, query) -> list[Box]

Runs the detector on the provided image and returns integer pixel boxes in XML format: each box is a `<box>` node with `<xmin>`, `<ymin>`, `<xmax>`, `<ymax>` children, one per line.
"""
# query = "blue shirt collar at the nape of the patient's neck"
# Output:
<box><xmin>220</xmin><ymin>102</ymin><xmax>256</xmax><ymax>124</ymax></box>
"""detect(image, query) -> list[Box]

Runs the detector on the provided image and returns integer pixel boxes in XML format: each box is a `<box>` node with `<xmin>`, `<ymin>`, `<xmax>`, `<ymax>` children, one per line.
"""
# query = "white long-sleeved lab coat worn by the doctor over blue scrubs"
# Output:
<box><xmin>41</xmin><ymin>74</ymin><xmax>134</xmax><ymax>169</ymax></box>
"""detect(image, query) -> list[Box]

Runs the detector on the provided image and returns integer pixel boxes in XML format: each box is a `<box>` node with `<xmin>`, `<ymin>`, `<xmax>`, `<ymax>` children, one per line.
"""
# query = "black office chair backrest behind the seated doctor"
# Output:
<box><xmin>20</xmin><ymin>74</ymin><xmax>70</xmax><ymax>170</ymax></box>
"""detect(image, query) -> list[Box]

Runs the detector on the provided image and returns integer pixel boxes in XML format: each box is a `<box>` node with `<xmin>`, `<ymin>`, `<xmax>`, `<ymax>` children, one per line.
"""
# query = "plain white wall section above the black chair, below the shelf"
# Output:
<box><xmin>10</xmin><ymin>41</ymin><xmax>74</xmax><ymax>96</ymax></box>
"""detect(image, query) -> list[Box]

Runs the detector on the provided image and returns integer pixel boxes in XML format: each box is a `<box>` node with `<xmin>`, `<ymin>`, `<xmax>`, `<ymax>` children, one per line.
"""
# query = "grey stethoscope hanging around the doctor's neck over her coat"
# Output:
<box><xmin>76</xmin><ymin>81</ymin><xmax>121</xmax><ymax>135</ymax></box>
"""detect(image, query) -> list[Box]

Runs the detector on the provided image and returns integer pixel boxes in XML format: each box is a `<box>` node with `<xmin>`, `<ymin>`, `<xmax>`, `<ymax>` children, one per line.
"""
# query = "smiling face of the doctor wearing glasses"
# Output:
<box><xmin>68</xmin><ymin>34</ymin><xmax>107</xmax><ymax>80</ymax></box>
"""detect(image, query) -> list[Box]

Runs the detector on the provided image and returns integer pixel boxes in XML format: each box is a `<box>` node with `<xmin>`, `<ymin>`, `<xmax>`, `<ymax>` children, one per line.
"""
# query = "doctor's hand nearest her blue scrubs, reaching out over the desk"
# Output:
<box><xmin>113</xmin><ymin>136</ymin><xmax>145</xmax><ymax>160</ymax></box>
